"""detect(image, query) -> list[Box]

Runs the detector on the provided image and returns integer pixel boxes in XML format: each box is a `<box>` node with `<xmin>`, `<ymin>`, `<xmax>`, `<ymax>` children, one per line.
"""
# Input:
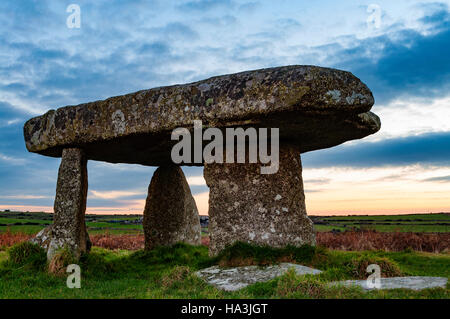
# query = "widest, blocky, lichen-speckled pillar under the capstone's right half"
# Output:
<box><xmin>204</xmin><ymin>146</ymin><xmax>315</xmax><ymax>255</ymax></box>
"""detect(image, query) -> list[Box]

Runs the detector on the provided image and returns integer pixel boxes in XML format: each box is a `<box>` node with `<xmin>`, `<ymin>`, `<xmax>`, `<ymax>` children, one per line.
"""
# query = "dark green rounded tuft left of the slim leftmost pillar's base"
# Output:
<box><xmin>8</xmin><ymin>241</ymin><xmax>47</xmax><ymax>270</ymax></box>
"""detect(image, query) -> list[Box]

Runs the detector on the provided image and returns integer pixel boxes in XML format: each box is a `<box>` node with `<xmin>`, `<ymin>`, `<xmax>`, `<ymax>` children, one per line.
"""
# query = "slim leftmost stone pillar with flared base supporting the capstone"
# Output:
<box><xmin>32</xmin><ymin>148</ymin><xmax>91</xmax><ymax>259</ymax></box>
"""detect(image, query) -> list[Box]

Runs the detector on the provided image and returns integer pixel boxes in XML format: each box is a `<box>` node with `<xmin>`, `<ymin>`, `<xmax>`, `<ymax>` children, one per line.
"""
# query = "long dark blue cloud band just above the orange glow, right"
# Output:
<box><xmin>302</xmin><ymin>132</ymin><xmax>450</xmax><ymax>168</ymax></box>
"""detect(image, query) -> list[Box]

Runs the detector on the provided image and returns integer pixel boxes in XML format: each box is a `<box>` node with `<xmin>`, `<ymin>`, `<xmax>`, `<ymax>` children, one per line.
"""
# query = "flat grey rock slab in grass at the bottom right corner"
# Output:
<box><xmin>332</xmin><ymin>276</ymin><xmax>447</xmax><ymax>290</ymax></box>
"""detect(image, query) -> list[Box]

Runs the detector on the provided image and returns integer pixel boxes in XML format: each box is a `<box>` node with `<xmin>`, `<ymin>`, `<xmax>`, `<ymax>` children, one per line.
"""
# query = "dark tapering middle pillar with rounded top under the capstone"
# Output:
<box><xmin>143</xmin><ymin>165</ymin><xmax>201</xmax><ymax>249</ymax></box>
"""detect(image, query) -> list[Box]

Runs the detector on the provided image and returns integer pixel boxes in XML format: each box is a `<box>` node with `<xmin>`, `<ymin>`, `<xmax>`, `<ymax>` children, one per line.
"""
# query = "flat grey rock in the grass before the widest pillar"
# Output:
<box><xmin>196</xmin><ymin>263</ymin><xmax>321</xmax><ymax>291</ymax></box>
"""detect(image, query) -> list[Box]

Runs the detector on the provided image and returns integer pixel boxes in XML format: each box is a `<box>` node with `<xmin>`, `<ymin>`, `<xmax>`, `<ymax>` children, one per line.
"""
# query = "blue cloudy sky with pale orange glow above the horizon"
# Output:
<box><xmin>0</xmin><ymin>0</ymin><xmax>450</xmax><ymax>215</ymax></box>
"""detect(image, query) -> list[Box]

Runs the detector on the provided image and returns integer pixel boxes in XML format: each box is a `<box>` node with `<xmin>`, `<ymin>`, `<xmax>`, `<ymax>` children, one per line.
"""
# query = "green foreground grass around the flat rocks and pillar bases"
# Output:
<box><xmin>0</xmin><ymin>244</ymin><xmax>450</xmax><ymax>299</ymax></box>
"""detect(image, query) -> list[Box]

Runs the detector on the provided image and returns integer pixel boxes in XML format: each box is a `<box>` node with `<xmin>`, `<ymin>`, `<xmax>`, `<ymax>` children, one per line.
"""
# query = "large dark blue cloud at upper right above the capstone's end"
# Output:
<box><xmin>330</xmin><ymin>4</ymin><xmax>450</xmax><ymax>104</ymax></box>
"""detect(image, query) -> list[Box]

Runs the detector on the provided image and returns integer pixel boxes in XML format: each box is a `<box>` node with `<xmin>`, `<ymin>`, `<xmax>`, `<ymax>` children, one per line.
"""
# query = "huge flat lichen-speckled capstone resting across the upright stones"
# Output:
<box><xmin>24</xmin><ymin>65</ymin><xmax>380</xmax><ymax>166</ymax></box>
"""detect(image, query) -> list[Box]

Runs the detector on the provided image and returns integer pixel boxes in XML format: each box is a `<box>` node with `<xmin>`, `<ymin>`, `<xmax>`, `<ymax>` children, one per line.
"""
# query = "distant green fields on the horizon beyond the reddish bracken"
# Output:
<box><xmin>0</xmin><ymin>211</ymin><xmax>450</xmax><ymax>235</ymax></box>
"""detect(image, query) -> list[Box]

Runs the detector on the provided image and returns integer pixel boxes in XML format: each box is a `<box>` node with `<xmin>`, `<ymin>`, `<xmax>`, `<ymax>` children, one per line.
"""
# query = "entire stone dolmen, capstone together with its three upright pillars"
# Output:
<box><xmin>24</xmin><ymin>65</ymin><xmax>380</xmax><ymax>258</ymax></box>
